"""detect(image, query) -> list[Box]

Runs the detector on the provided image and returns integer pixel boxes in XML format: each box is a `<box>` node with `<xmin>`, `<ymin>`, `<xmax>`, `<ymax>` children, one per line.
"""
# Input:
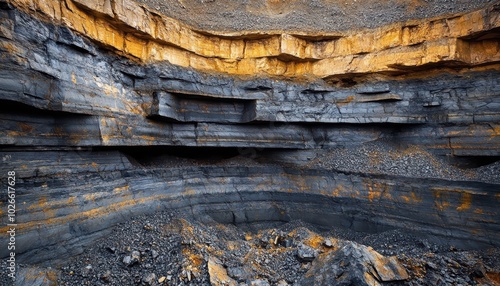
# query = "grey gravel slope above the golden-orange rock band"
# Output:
<box><xmin>137</xmin><ymin>0</ymin><xmax>498</xmax><ymax>32</ymax></box>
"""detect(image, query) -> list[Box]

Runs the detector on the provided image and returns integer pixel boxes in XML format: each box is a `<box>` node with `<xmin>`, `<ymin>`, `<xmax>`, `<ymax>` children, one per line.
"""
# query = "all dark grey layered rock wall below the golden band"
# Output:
<box><xmin>0</xmin><ymin>1</ymin><xmax>500</xmax><ymax>263</ymax></box>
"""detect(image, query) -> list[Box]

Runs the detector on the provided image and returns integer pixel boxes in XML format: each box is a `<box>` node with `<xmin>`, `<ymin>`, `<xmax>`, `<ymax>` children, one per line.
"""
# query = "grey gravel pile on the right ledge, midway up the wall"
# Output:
<box><xmin>307</xmin><ymin>141</ymin><xmax>500</xmax><ymax>183</ymax></box>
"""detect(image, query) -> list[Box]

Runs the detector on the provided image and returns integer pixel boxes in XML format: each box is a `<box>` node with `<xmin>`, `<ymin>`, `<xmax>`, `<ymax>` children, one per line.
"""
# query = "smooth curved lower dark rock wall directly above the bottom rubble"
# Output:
<box><xmin>1</xmin><ymin>151</ymin><xmax>500</xmax><ymax>262</ymax></box>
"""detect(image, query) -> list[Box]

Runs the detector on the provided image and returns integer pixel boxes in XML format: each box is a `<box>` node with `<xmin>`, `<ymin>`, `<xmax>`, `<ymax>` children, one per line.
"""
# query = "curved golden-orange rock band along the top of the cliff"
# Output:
<box><xmin>5</xmin><ymin>0</ymin><xmax>500</xmax><ymax>78</ymax></box>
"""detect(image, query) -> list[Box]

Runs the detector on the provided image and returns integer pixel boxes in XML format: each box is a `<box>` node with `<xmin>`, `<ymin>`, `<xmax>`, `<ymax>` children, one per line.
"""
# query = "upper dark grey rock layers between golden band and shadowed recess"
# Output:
<box><xmin>0</xmin><ymin>4</ymin><xmax>500</xmax><ymax>156</ymax></box>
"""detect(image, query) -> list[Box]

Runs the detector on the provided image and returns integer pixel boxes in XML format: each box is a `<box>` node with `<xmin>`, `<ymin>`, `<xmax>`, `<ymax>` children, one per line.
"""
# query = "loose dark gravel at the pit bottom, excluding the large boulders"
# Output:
<box><xmin>49</xmin><ymin>209</ymin><xmax>500</xmax><ymax>286</ymax></box>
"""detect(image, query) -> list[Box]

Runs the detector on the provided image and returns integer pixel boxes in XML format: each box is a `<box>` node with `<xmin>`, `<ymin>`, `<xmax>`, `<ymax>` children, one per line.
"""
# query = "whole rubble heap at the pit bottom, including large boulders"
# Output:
<box><xmin>28</xmin><ymin>212</ymin><xmax>500</xmax><ymax>286</ymax></box>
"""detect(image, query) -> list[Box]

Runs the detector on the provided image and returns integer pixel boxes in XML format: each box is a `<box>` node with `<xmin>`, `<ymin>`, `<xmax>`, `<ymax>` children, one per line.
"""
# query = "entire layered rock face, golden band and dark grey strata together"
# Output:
<box><xmin>0</xmin><ymin>0</ymin><xmax>500</xmax><ymax>274</ymax></box>
